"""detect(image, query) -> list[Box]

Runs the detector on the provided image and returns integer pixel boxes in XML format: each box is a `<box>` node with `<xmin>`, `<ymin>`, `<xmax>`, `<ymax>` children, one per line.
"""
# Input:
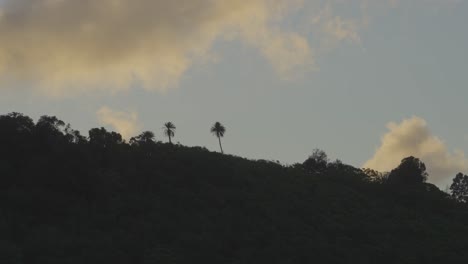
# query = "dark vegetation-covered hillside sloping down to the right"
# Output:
<box><xmin>0</xmin><ymin>113</ymin><xmax>468</xmax><ymax>264</ymax></box>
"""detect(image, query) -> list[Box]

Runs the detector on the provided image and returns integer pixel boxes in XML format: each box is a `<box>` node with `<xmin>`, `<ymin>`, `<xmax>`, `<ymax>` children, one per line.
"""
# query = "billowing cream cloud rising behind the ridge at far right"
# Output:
<box><xmin>363</xmin><ymin>117</ymin><xmax>468</xmax><ymax>187</ymax></box>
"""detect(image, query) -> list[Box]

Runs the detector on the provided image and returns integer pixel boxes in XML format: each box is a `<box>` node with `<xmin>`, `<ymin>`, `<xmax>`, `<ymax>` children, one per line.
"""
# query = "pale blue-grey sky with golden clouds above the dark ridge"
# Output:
<box><xmin>0</xmin><ymin>0</ymin><xmax>468</xmax><ymax>188</ymax></box>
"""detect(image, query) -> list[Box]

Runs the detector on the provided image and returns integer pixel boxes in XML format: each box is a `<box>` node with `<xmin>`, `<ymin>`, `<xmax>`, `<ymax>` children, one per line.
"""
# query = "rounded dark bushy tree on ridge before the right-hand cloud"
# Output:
<box><xmin>388</xmin><ymin>156</ymin><xmax>428</xmax><ymax>185</ymax></box>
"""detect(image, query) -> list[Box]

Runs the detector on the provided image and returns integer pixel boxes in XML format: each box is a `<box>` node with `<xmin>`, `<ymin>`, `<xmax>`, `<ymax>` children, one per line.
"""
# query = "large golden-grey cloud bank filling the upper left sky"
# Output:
<box><xmin>0</xmin><ymin>0</ymin><xmax>314</xmax><ymax>95</ymax></box>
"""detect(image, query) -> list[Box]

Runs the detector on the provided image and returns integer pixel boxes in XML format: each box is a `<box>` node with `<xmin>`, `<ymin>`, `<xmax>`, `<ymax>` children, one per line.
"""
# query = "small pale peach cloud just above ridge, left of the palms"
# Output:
<box><xmin>96</xmin><ymin>106</ymin><xmax>140</xmax><ymax>139</ymax></box>
